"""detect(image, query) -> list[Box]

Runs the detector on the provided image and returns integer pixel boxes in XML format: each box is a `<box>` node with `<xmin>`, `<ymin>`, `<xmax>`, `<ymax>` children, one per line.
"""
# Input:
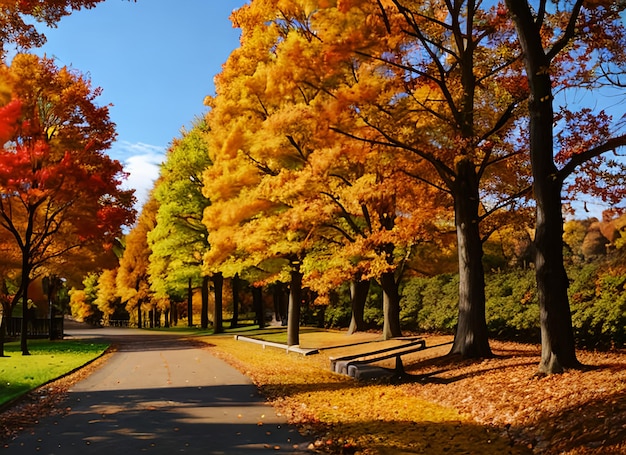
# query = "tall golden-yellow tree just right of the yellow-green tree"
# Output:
<box><xmin>204</xmin><ymin>3</ymin><xmax>313</xmax><ymax>344</ymax></box>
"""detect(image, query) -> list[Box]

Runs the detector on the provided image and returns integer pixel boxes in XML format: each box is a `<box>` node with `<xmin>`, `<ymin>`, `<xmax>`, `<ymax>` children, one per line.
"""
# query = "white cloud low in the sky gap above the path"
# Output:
<box><xmin>109</xmin><ymin>141</ymin><xmax>165</xmax><ymax>211</ymax></box>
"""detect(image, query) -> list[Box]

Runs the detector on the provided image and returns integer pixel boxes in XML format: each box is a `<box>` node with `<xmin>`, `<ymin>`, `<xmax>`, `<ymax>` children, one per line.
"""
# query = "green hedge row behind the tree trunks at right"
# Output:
<box><xmin>324</xmin><ymin>263</ymin><xmax>626</xmax><ymax>349</ymax></box>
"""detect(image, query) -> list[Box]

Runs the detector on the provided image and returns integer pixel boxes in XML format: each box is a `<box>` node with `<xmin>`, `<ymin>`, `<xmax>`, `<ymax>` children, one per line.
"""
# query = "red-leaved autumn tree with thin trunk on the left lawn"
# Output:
<box><xmin>0</xmin><ymin>54</ymin><xmax>134</xmax><ymax>355</ymax></box>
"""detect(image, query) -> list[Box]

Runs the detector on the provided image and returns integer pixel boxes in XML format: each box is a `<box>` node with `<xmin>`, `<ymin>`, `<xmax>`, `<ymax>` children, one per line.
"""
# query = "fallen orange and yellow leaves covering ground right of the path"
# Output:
<box><xmin>206</xmin><ymin>335</ymin><xmax>626</xmax><ymax>455</ymax></box>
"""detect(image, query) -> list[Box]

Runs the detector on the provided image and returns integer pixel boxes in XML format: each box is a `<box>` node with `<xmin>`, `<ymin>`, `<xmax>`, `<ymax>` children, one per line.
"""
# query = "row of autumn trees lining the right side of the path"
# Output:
<box><xmin>4</xmin><ymin>0</ymin><xmax>626</xmax><ymax>373</ymax></box>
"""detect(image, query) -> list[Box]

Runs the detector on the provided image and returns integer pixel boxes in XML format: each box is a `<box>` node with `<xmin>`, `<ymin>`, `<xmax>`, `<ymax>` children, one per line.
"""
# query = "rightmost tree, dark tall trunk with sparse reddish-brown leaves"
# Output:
<box><xmin>506</xmin><ymin>0</ymin><xmax>626</xmax><ymax>374</ymax></box>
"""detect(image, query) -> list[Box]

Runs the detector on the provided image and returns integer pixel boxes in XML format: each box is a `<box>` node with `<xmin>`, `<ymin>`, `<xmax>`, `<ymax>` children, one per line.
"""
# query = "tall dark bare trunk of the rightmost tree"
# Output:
<box><xmin>506</xmin><ymin>0</ymin><xmax>580</xmax><ymax>374</ymax></box>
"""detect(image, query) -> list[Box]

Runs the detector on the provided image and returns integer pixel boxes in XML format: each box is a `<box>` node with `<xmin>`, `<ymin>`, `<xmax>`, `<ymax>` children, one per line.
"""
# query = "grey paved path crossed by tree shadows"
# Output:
<box><xmin>2</xmin><ymin>329</ymin><xmax>311</xmax><ymax>455</ymax></box>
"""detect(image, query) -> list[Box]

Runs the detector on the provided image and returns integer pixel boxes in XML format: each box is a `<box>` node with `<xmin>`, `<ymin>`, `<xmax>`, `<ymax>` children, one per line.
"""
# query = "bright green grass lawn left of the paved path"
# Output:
<box><xmin>0</xmin><ymin>340</ymin><xmax>109</xmax><ymax>406</ymax></box>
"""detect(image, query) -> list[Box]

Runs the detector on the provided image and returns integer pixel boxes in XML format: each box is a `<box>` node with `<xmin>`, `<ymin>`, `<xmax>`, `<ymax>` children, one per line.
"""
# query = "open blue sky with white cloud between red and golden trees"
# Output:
<box><xmin>34</xmin><ymin>0</ymin><xmax>247</xmax><ymax>210</ymax></box>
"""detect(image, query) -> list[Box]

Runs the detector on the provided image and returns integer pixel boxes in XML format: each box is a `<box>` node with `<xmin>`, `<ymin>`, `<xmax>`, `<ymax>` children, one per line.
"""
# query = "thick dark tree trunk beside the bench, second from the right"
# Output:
<box><xmin>450</xmin><ymin>159</ymin><xmax>493</xmax><ymax>358</ymax></box>
